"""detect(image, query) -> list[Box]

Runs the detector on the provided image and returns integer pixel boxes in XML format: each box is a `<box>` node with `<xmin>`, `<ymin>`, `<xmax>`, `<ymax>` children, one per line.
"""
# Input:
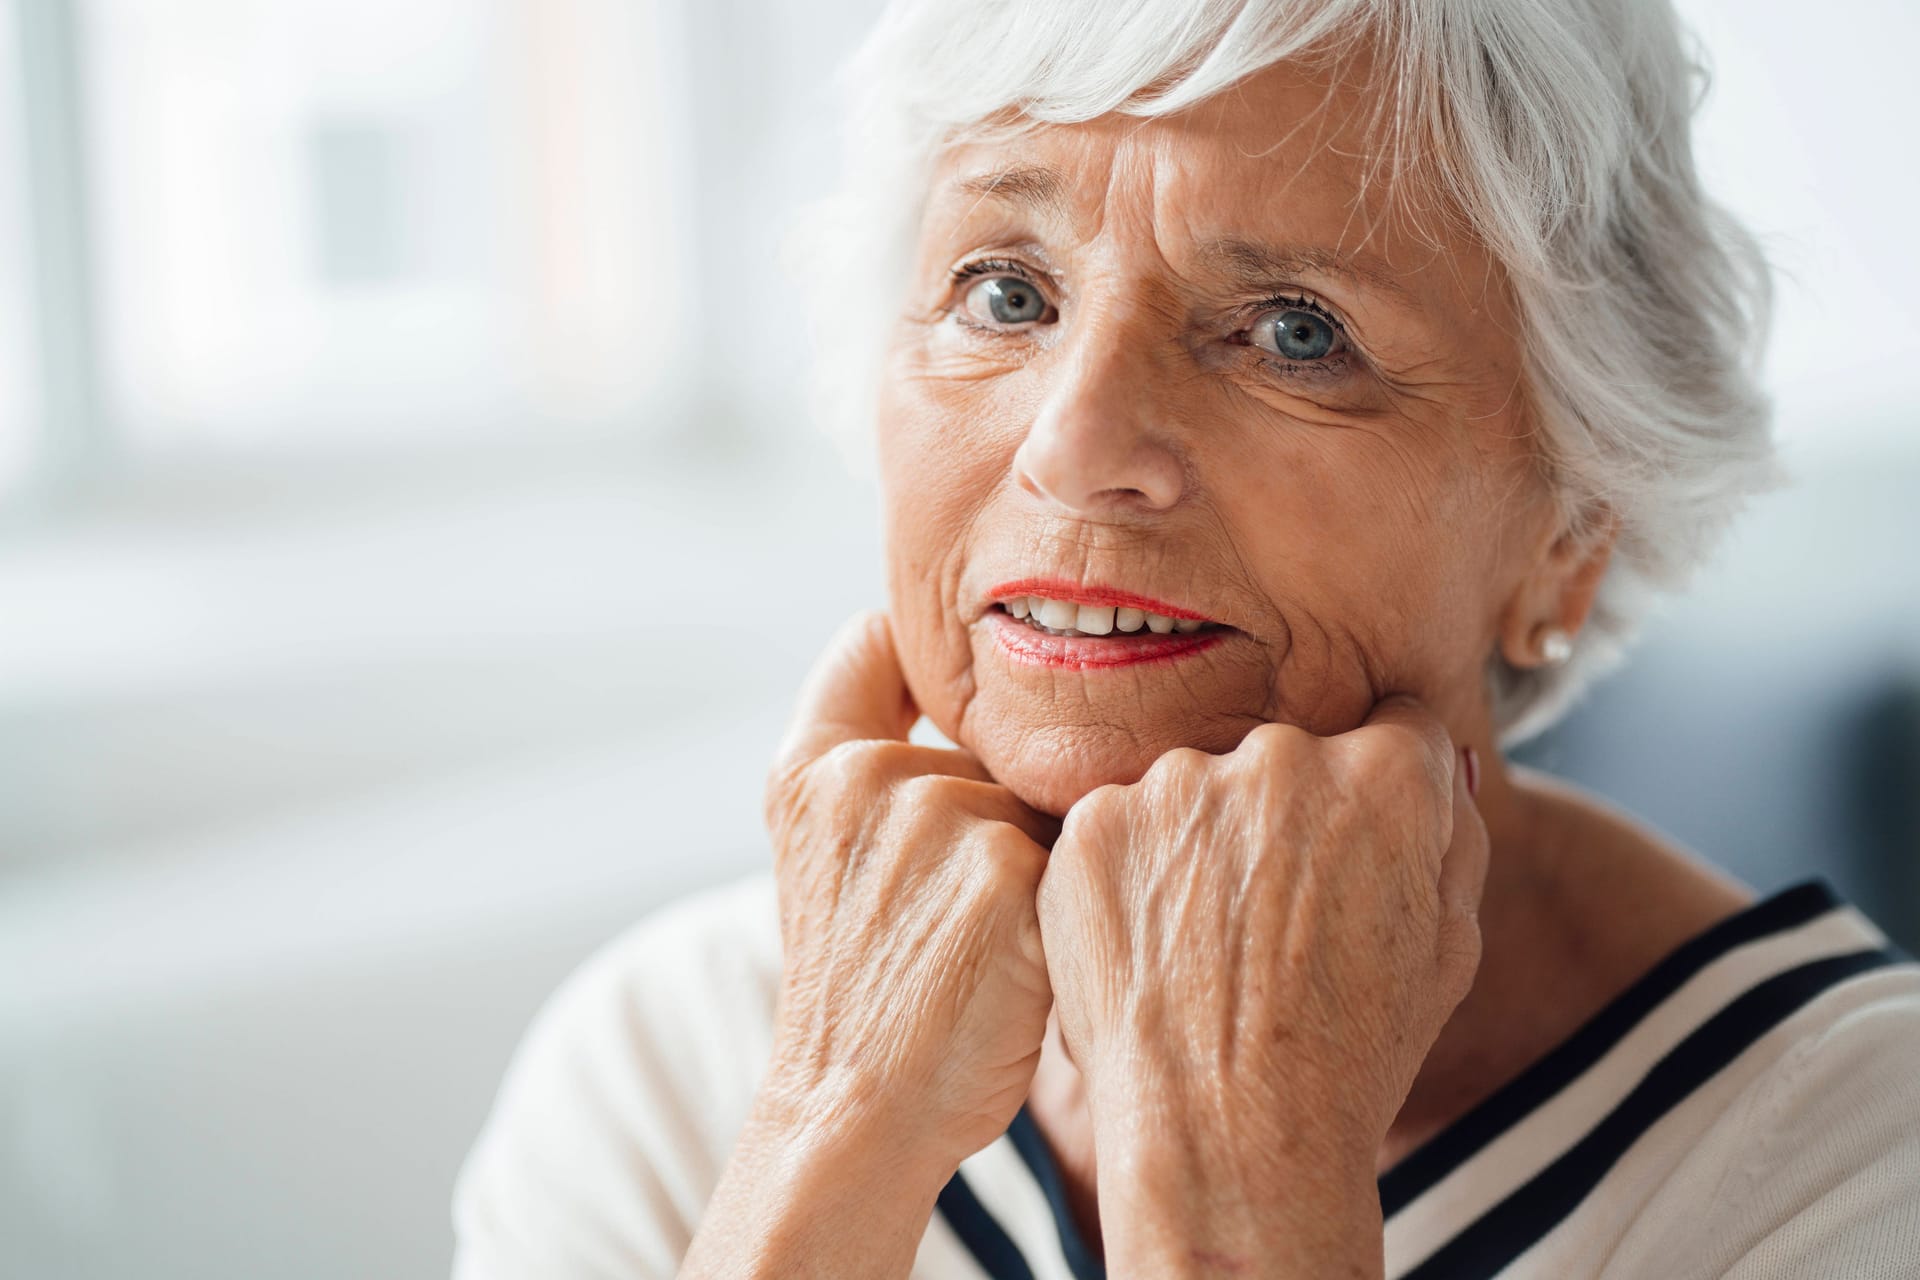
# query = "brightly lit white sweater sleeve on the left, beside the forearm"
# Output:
<box><xmin>453</xmin><ymin>879</ymin><xmax>778</xmax><ymax>1280</ymax></box>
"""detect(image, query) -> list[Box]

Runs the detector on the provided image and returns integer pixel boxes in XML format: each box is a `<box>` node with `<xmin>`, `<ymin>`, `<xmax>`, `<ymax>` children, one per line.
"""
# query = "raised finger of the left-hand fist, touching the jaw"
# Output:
<box><xmin>780</xmin><ymin>608</ymin><xmax>920</xmax><ymax>764</ymax></box>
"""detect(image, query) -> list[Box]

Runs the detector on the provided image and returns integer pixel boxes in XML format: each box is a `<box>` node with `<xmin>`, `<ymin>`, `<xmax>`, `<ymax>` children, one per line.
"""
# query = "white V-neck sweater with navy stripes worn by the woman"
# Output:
<box><xmin>455</xmin><ymin>877</ymin><xmax>1920</xmax><ymax>1280</ymax></box>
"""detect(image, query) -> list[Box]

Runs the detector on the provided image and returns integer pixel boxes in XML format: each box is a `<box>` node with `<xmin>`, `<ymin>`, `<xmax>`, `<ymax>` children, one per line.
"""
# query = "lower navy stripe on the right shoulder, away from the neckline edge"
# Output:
<box><xmin>1405</xmin><ymin>948</ymin><xmax>1901</xmax><ymax>1280</ymax></box>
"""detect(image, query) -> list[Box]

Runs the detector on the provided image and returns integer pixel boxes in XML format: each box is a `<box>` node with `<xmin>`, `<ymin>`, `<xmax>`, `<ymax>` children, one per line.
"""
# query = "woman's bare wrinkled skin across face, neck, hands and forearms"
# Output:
<box><xmin>684</xmin><ymin>52</ymin><xmax>1738</xmax><ymax>1276</ymax></box>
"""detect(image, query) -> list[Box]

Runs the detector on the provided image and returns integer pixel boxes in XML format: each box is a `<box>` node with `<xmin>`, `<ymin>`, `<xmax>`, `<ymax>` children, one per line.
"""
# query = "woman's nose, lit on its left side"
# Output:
<box><xmin>1014</xmin><ymin>313</ymin><xmax>1187</xmax><ymax>518</ymax></box>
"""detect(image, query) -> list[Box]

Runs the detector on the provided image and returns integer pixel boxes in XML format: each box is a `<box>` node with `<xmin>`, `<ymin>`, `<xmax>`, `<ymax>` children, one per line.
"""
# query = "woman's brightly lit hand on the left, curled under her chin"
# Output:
<box><xmin>766</xmin><ymin>612</ymin><xmax>1058</xmax><ymax>1182</ymax></box>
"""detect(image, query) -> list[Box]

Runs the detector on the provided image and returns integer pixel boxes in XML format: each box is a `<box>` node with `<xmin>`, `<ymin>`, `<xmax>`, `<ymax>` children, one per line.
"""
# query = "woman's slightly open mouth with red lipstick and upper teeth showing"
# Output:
<box><xmin>989</xmin><ymin>581</ymin><xmax>1233</xmax><ymax>670</ymax></box>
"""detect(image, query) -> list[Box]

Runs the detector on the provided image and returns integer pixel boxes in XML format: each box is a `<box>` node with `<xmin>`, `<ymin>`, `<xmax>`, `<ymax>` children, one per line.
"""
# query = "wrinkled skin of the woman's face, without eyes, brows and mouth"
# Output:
<box><xmin>879</xmin><ymin>59</ymin><xmax>1572</xmax><ymax>814</ymax></box>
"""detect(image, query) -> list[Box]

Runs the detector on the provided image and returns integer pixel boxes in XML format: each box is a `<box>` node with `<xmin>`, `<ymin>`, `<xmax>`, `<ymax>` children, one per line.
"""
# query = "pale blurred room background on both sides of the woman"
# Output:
<box><xmin>0</xmin><ymin>0</ymin><xmax>1920</xmax><ymax>1280</ymax></box>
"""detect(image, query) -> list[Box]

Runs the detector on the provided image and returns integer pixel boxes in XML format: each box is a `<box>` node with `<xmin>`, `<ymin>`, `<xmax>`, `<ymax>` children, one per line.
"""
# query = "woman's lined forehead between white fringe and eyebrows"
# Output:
<box><xmin>927</xmin><ymin>61</ymin><xmax>1486</xmax><ymax>288</ymax></box>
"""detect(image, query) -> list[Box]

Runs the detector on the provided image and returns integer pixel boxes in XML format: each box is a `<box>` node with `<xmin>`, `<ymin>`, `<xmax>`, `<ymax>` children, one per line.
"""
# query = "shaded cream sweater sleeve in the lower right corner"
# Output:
<box><xmin>1701</xmin><ymin>967</ymin><xmax>1920</xmax><ymax>1280</ymax></box>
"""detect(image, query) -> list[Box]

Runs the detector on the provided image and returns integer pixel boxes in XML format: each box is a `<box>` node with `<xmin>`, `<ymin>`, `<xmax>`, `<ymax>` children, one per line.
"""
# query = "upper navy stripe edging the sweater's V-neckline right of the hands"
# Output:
<box><xmin>1380</xmin><ymin>881</ymin><xmax>1839</xmax><ymax>1217</ymax></box>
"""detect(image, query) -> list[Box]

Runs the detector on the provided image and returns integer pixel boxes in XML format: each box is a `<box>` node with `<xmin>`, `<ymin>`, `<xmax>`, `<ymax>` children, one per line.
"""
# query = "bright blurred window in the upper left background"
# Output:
<box><xmin>81</xmin><ymin>0</ymin><xmax>685</xmax><ymax>455</ymax></box>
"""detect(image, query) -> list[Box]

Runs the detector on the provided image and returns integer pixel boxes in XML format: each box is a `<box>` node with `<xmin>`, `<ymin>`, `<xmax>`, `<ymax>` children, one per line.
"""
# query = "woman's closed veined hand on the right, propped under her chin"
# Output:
<box><xmin>1041</xmin><ymin>697</ymin><xmax>1486</xmax><ymax>1274</ymax></box>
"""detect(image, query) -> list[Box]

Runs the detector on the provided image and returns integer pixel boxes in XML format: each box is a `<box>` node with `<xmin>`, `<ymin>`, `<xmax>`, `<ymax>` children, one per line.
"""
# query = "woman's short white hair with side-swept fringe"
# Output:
<box><xmin>793</xmin><ymin>0</ymin><xmax>1778</xmax><ymax>745</ymax></box>
